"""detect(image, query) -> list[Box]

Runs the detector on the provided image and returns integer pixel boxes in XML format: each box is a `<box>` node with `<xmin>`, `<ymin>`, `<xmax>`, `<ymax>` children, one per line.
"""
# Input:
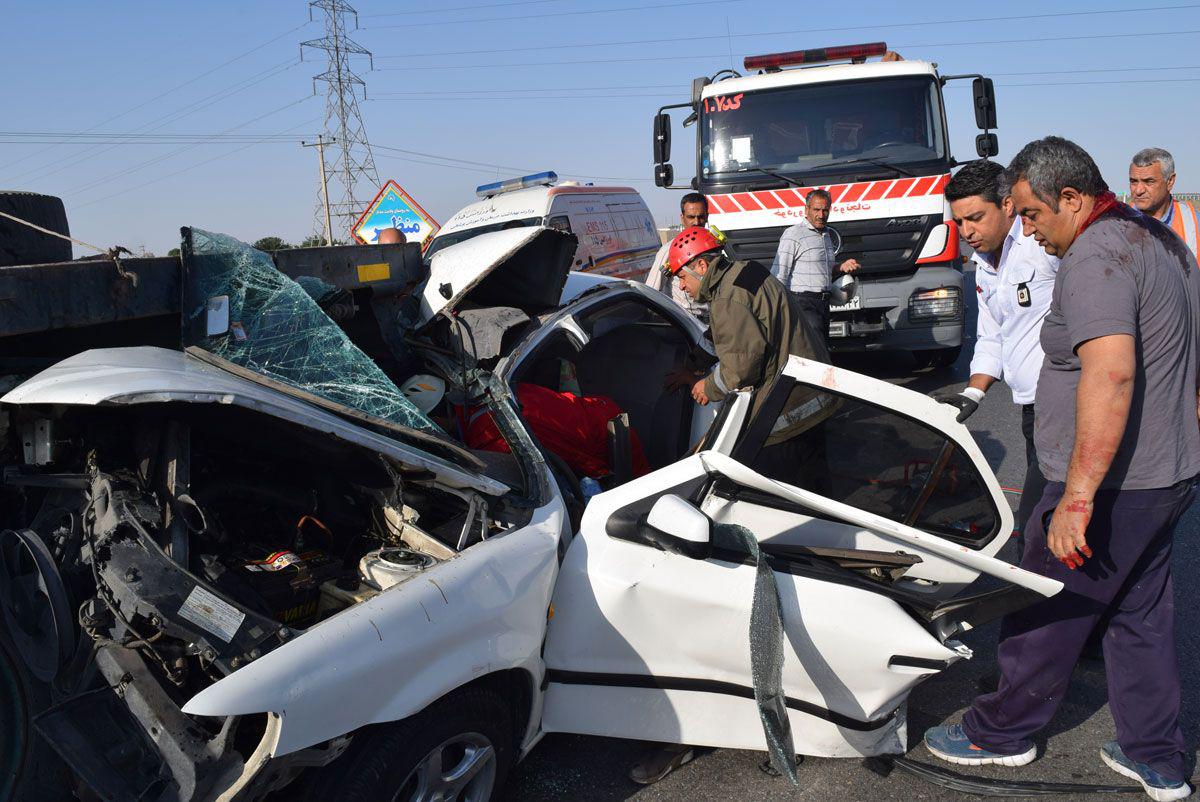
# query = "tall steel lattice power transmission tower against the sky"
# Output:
<box><xmin>300</xmin><ymin>0</ymin><xmax>379</xmax><ymax>240</ymax></box>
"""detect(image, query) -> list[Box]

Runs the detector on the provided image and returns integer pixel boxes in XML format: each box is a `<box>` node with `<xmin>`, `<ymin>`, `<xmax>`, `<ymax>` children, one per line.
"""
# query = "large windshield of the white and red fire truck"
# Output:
<box><xmin>700</xmin><ymin>76</ymin><xmax>946</xmax><ymax>180</ymax></box>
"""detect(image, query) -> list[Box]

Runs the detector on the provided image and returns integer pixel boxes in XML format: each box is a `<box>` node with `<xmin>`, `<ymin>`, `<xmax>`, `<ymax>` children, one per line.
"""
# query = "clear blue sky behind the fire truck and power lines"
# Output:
<box><xmin>0</xmin><ymin>0</ymin><xmax>1200</xmax><ymax>253</ymax></box>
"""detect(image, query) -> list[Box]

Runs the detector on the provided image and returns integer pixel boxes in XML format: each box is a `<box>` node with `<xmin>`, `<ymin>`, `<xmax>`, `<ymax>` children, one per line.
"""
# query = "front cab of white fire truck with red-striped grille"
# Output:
<box><xmin>654</xmin><ymin>42</ymin><xmax>997</xmax><ymax>366</ymax></box>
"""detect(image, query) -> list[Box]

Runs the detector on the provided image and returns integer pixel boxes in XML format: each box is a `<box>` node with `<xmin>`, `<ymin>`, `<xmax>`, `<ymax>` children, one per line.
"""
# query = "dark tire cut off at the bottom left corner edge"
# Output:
<box><xmin>0</xmin><ymin>621</ymin><xmax>72</xmax><ymax>802</ymax></box>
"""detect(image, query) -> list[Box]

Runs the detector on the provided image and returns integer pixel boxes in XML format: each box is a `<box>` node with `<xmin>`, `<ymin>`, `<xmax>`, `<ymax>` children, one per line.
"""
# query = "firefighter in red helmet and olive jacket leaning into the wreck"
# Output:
<box><xmin>664</xmin><ymin>226</ymin><xmax>829</xmax><ymax>405</ymax></box>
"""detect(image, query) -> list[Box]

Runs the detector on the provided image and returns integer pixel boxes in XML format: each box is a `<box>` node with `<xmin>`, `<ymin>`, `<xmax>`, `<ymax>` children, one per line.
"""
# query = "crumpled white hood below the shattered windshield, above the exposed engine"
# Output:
<box><xmin>0</xmin><ymin>346</ymin><xmax>509</xmax><ymax>496</ymax></box>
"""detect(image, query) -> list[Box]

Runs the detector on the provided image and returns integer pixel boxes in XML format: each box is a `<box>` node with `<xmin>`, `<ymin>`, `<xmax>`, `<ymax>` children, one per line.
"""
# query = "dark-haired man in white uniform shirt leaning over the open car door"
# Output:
<box><xmin>934</xmin><ymin>160</ymin><xmax>1058</xmax><ymax>545</ymax></box>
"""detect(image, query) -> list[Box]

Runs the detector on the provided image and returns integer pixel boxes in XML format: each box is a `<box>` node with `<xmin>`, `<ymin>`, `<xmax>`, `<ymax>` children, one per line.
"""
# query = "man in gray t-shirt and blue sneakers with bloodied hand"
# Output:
<box><xmin>925</xmin><ymin>137</ymin><xmax>1200</xmax><ymax>800</ymax></box>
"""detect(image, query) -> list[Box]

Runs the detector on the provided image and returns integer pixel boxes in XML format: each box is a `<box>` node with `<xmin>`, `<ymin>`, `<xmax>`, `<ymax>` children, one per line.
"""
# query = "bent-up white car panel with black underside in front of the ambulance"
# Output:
<box><xmin>420</xmin><ymin>227</ymin><xmax>577</xmax><ymax>325</ymax></box>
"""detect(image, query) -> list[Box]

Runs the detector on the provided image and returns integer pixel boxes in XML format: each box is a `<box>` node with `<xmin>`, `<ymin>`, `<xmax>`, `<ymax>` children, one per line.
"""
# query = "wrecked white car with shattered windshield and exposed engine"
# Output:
<box><xmin>0</xmin><ymin>229</ymin><xmax>1058</xmax><ymax>801</ymax></box>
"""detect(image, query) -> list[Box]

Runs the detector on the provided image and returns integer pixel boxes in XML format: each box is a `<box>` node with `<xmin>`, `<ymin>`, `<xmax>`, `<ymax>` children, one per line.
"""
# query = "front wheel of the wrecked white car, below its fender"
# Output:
<box><xmin>301</xmin><ymin>688</ymin><xmax>516</xmax><ymax>802</ymax></box>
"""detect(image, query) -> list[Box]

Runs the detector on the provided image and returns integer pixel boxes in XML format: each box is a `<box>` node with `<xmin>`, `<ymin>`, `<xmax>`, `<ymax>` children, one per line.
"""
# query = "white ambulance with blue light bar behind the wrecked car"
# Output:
<box><xmin>425</xmin><ymin>172</ymin><xmax>661</xmax><ymax>281</ymax></box>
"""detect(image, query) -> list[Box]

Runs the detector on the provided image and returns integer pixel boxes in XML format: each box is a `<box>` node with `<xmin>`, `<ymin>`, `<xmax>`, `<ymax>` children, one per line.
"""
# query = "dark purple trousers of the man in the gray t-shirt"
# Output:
<box><xmin>962</xmin><ymin>479</ymin><xmax>1196</xmax><ymax>779</ymax></box>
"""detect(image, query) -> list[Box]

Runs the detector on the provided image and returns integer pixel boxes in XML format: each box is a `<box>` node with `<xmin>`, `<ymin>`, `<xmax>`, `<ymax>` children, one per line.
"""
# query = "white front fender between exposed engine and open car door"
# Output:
<box><xmin>184</xmin><ymin>498</ymin><xmax>564</xmax><ymax>756</ymax></box>
